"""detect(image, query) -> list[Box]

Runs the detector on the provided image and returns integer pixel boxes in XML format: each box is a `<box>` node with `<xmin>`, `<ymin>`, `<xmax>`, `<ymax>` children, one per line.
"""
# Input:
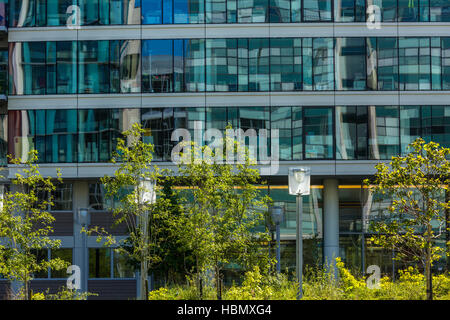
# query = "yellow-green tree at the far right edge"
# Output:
<box><xmin>365</xmin><ymin>138</ymin><xmax>450</xmax><ymax>300</ymax></box>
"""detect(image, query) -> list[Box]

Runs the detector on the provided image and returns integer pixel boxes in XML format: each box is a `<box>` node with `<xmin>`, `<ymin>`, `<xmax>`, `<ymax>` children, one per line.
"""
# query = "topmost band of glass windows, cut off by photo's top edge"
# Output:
<box><xmin>9</xmin><ymin>0</ymin><xmax>450</xmax><ymax>27</ymax></box>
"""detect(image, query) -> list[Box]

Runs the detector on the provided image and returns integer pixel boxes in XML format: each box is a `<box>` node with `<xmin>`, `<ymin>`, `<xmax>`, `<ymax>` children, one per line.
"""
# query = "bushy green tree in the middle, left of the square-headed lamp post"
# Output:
<box><xmin>173</xmin><ymin>127</ymin><xmax>270</xmax><ymax>299</ymax></box>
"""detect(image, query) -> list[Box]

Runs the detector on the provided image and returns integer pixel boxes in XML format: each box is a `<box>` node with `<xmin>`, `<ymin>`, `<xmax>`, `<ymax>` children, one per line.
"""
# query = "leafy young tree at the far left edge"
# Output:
<box><xmin>0</xmin><ymin>150</ymin><xmax>68</xmax><ymax>300</ymax></box>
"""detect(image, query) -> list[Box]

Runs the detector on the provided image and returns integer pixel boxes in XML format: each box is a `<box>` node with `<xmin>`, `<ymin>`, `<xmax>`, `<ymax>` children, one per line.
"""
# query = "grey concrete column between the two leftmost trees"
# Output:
<box><xmin>73</xmin><ymin>181</ymin><xmax>89</xmax><ymax>292</ymax></box>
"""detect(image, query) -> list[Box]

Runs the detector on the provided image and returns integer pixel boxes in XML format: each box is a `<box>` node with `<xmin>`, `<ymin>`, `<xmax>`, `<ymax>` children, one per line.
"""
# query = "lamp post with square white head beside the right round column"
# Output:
<box><xmin>289</xmin><ymin>167</ymin><xmax>311</xmax><ymax>300</ymax></box>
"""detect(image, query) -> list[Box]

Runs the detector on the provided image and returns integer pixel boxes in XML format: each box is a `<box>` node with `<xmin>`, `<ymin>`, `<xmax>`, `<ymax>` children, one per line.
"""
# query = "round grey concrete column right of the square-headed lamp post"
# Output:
<box><xmin>323</xmin><ymin>179</ymin><xmax>339</xmax><ymax>274</ymax></box>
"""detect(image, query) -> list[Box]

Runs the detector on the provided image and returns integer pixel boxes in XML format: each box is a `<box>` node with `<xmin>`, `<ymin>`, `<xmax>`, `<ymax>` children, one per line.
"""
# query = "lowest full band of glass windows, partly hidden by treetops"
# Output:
<box><xmin>7</xmin><ymin>106</ymin><xmax>450</xmax><ymax>163</ymax></box>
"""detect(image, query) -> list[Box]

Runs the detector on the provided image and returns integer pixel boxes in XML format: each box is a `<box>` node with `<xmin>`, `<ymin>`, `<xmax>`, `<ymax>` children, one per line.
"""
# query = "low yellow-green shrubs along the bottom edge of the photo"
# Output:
<box><xmin>150</xmin><ymin>259</ymin><xmax>450</xmax><ymax>300</ymax></box>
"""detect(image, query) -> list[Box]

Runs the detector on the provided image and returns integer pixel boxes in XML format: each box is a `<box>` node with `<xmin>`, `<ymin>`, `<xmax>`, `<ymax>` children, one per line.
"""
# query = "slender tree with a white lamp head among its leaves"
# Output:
<box><xmin>88</xmin><ymin>123</ymin><xmax>170</xmax><ymax>300</ymax></box>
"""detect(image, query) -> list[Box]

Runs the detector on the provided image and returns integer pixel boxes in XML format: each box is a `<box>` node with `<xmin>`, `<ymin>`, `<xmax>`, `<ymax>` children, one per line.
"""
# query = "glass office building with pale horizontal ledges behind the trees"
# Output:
<box><xmin>0</xmin><ymin>0</ymin><xmax>450</xmax><ymax>299</ymax></box>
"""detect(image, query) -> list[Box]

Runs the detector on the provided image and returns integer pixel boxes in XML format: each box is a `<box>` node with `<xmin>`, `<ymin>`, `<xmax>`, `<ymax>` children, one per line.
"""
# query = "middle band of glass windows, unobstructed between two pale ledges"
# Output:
<box><xmin>9</xmin><ymin>37</ymin><xmax>450</xmax><ymax>95</ymax></box>
